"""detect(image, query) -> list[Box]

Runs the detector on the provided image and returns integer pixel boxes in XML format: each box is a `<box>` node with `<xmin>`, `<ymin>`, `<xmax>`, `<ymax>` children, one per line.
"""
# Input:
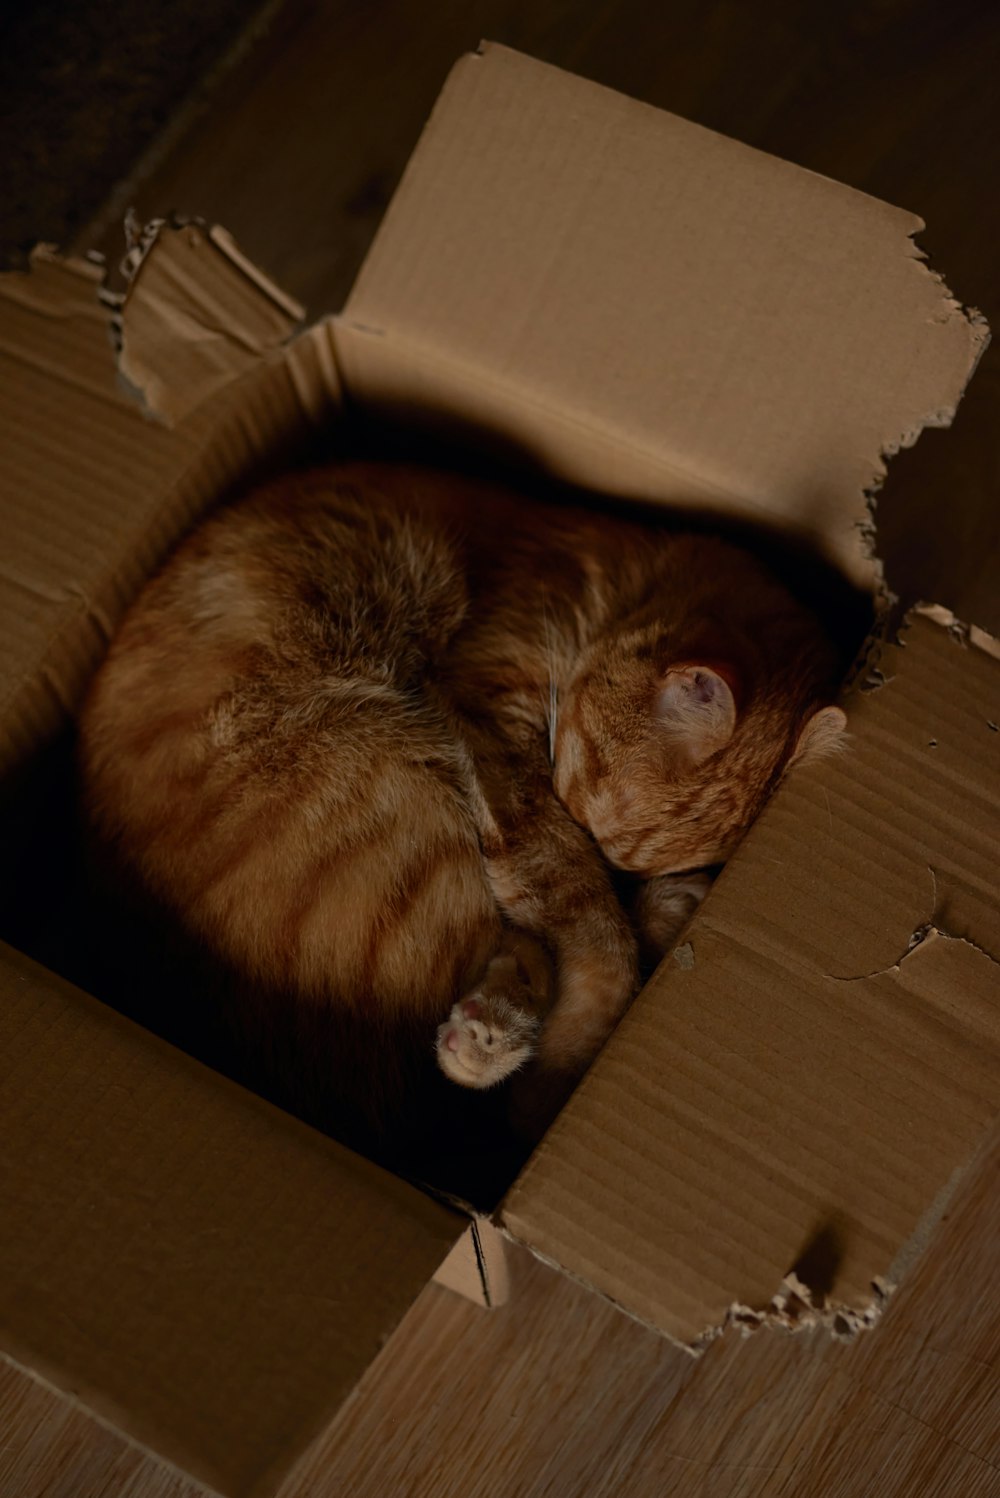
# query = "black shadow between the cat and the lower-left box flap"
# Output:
<box><xmin>0</xmin><ymin>731</ymin><xmax>538</xmax><ymax>1210</ymax></box>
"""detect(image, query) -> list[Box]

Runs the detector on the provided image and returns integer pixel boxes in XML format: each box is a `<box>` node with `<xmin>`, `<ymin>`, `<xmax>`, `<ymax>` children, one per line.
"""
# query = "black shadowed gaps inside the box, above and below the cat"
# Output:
<box><xmin>0</xmin><ymin>409</ymin><xmax>871</xmax><ymax>1210</ymax></box>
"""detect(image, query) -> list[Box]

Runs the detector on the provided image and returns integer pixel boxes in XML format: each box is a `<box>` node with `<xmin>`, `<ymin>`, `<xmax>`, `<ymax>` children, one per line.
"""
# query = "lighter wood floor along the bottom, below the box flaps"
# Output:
<box><xmin>0</xmin><ymin>1129</ymin><xmax>1000</xmax><ymax>1498</ymax></box>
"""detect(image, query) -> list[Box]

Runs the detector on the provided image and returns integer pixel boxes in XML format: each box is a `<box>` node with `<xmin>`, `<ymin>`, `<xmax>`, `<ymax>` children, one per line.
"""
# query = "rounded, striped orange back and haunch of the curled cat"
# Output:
<box><xmin>81</xmin><ymin>467</ymin><xmax>497</xmax><ymax>1016</ymax></box>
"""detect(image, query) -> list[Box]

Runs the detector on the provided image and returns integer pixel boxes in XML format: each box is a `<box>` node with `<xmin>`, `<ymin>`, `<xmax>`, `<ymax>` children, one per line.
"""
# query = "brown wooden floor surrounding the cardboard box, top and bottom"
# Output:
<box><xmin>0</xmin><ymin>0</ymin><xmax>1000</xmax><ymax>1498</ymax></box>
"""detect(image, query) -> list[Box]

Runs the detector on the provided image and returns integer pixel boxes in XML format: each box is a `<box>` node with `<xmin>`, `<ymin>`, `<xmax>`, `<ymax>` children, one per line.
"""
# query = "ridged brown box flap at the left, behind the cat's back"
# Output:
<box><xmin>0</xmin><ymin>240</ymin><xmax>338</xmax><ymax>771</ymax></box>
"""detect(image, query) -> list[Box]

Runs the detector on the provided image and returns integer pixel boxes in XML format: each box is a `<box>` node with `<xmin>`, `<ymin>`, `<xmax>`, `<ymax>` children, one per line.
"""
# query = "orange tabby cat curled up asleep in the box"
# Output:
<box><xmin>81</xmin><ymin>463</ymin><xmax>844</xmax><ymax>1126</ymax></box>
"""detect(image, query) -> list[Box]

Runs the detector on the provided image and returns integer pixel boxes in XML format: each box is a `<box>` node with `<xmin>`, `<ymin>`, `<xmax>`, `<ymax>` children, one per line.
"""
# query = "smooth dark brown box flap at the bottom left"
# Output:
<box><xmin>0</xmin><ymin>947</ymin><xmax>467</xmax><ymax>1498</ymax></box>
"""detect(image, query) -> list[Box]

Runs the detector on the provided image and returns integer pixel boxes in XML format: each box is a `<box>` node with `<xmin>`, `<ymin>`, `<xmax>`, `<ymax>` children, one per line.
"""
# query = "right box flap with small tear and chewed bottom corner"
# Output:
<box><xmin>501</xmin><ymin>616</ymin><xmax>1000</xmax><ymax>1345</ymax></box>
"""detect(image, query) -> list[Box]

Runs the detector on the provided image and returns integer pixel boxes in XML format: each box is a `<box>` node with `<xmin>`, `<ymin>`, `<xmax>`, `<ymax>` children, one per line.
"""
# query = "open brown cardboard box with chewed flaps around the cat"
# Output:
<box><xmin>0</xmin><ymin>46</ymin><xmax>1000</xmax><ymax>1495</ymax></box>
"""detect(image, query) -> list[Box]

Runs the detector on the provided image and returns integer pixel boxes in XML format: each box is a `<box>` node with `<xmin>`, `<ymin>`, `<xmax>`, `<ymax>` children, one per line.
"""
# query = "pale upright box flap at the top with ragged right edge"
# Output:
<box><xmin>337</xmin><ymin>45</ymin><xmax>987</xmax><ymax>586</ymax></box>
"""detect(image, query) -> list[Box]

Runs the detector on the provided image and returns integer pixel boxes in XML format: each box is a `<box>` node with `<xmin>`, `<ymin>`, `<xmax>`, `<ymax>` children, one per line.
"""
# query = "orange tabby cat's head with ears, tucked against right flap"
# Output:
<box><xmin>552</xmin><ymin>641</ymin><xmax>846</xmax><ymax>878</ymax></box>
